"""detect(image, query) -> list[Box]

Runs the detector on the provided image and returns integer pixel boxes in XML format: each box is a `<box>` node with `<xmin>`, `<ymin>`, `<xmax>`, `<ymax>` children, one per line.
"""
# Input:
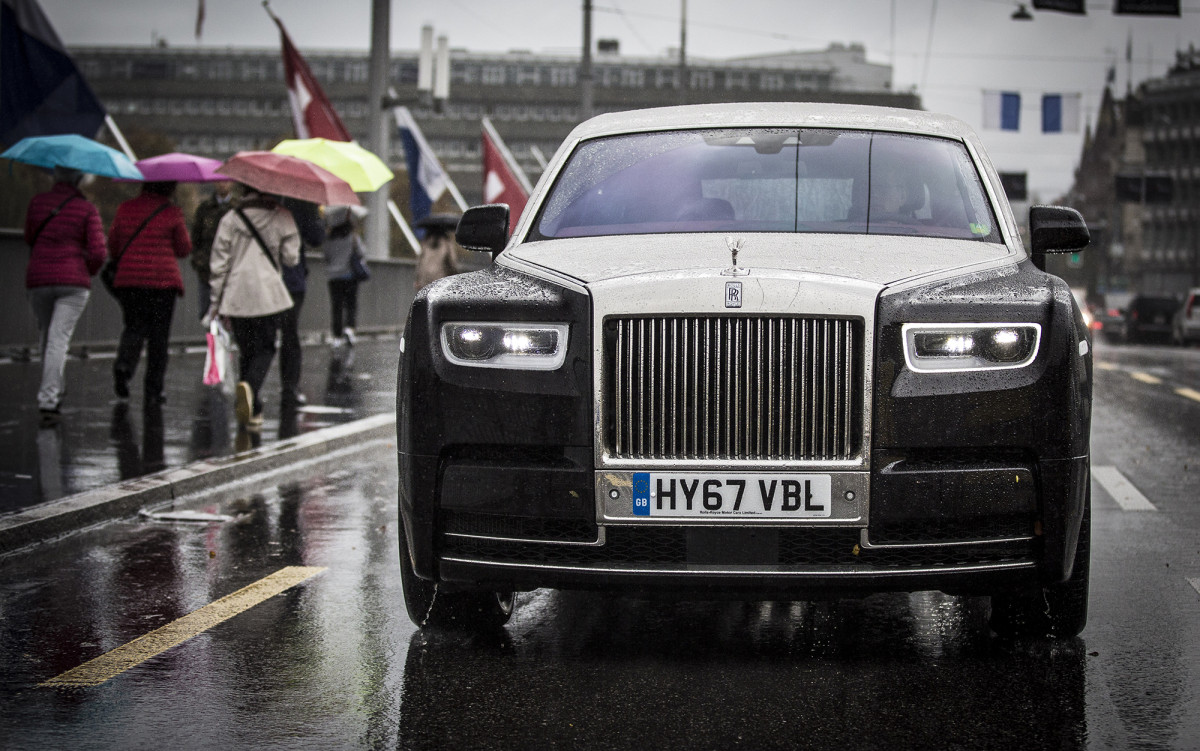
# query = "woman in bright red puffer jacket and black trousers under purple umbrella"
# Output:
<box><xmin>108</xmin><ymin>182</ymin><xmax>192</xmax><ymax>404</ymax></box>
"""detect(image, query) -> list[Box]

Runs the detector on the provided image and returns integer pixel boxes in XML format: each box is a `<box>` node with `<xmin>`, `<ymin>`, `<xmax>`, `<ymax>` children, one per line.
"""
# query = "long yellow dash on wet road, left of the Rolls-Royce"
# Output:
<box><xmin>38</xmin><ymin>566</ymin><xmax>325</xmax><ymax>686</ymax></box>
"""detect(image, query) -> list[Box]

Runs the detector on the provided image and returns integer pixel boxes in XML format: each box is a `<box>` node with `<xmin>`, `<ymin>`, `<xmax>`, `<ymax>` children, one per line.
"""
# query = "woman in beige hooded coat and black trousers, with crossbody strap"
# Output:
<box><xmin>206</xmin><ymin>186</ymin><xmax>300</xmax><ymax>429</ymax></box>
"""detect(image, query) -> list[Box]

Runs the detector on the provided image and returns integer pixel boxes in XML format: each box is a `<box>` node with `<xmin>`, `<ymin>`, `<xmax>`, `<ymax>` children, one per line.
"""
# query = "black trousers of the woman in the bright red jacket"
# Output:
<box><xmin>113</xmin><ymin>287</ymin><xmax>178</xmax><ymax>402</ymax></box>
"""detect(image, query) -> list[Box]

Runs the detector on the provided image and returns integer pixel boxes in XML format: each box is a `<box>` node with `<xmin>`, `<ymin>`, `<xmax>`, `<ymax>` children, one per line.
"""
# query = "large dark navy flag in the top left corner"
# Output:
<box><xmin>0</xmin><ymin>0</ymin><xmax>107</xmax><ymax>148</ymax></box>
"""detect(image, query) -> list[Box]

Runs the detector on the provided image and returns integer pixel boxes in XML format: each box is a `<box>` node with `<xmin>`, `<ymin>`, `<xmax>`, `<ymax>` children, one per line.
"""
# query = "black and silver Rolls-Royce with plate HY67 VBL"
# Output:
<box><xmin>396</xmin><ymin>103</ymin><xmax>1092</xmax><ymax>636</ymax></box>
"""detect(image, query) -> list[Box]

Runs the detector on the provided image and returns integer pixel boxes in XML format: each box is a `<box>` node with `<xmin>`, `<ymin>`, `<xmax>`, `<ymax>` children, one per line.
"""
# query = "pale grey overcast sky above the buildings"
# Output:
<box><xmin>38</xmin><ymin>0</ymin><xmax>1200</xmax><ymax>200</ymax></box>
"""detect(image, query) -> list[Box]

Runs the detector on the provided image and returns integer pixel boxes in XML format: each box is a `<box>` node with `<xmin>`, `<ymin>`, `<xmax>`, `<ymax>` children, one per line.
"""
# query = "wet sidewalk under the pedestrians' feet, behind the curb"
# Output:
<box><xmin>0</xmin><ymin>336</ymin><xmax>400</xmax><ymax>515</ymax></box>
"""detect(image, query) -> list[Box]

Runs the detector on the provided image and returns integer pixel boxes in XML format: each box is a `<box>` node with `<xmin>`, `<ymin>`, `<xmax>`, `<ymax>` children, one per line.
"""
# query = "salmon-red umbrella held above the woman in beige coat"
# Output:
<box><xmin>217</xmin><ymin>151</ymin><xmax>362</xmax><ymax>206</ymax></box>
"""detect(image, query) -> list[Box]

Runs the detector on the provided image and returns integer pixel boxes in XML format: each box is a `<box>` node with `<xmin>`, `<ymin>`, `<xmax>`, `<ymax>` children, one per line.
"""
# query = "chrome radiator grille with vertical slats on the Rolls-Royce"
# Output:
<box><xmin>605</xmin><ymin>317</ymin><xmax>863</xmax><ymax>461</ymax></box>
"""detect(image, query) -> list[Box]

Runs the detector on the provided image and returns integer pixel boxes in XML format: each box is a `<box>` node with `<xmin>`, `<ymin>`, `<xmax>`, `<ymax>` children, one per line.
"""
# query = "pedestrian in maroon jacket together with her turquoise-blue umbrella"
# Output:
<box><xmin>0</xmin><ymin>134</ymin><xmax>142</xmax><ymax>425</ymax></box>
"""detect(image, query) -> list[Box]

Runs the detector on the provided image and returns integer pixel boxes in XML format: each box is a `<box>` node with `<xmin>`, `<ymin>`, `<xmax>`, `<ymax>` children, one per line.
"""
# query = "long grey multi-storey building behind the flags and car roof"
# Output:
<box><xmin>72</xmin><ymin>44</ymin><xmax>920</xmax><ymax>203</ymax></box>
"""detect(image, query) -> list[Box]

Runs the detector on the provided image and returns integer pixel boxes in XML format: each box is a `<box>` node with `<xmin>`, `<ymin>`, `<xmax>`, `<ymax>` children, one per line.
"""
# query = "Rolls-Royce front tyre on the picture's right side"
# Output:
<box><xmin>991</xmin><ymin>480</ymin><xmax>1092</xmax><ymax>638</ymax></box>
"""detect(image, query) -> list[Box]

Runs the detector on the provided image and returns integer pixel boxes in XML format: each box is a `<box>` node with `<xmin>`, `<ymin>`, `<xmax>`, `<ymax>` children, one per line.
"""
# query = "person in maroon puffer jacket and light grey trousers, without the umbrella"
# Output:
<box><xmin>25</xmin><ymin>167</ymin><xmax>104</xmax><ymax>423</ymax></box>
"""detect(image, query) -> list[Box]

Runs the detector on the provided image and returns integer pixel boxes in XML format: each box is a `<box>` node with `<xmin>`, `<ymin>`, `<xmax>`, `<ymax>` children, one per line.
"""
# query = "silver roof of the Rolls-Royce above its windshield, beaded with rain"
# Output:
<box><xmin>569</xmin><ymin>102</ymin><xmax>977</xmax><ymax>140</ymax></box>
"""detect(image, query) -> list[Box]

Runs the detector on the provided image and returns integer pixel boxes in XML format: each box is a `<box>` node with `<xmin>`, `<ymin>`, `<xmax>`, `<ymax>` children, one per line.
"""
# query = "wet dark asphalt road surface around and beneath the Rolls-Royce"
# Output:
<box><xmin>0</xmin><ymin>335</ymin><xmax>1200</xmax><ymax>749</ymax></box>
